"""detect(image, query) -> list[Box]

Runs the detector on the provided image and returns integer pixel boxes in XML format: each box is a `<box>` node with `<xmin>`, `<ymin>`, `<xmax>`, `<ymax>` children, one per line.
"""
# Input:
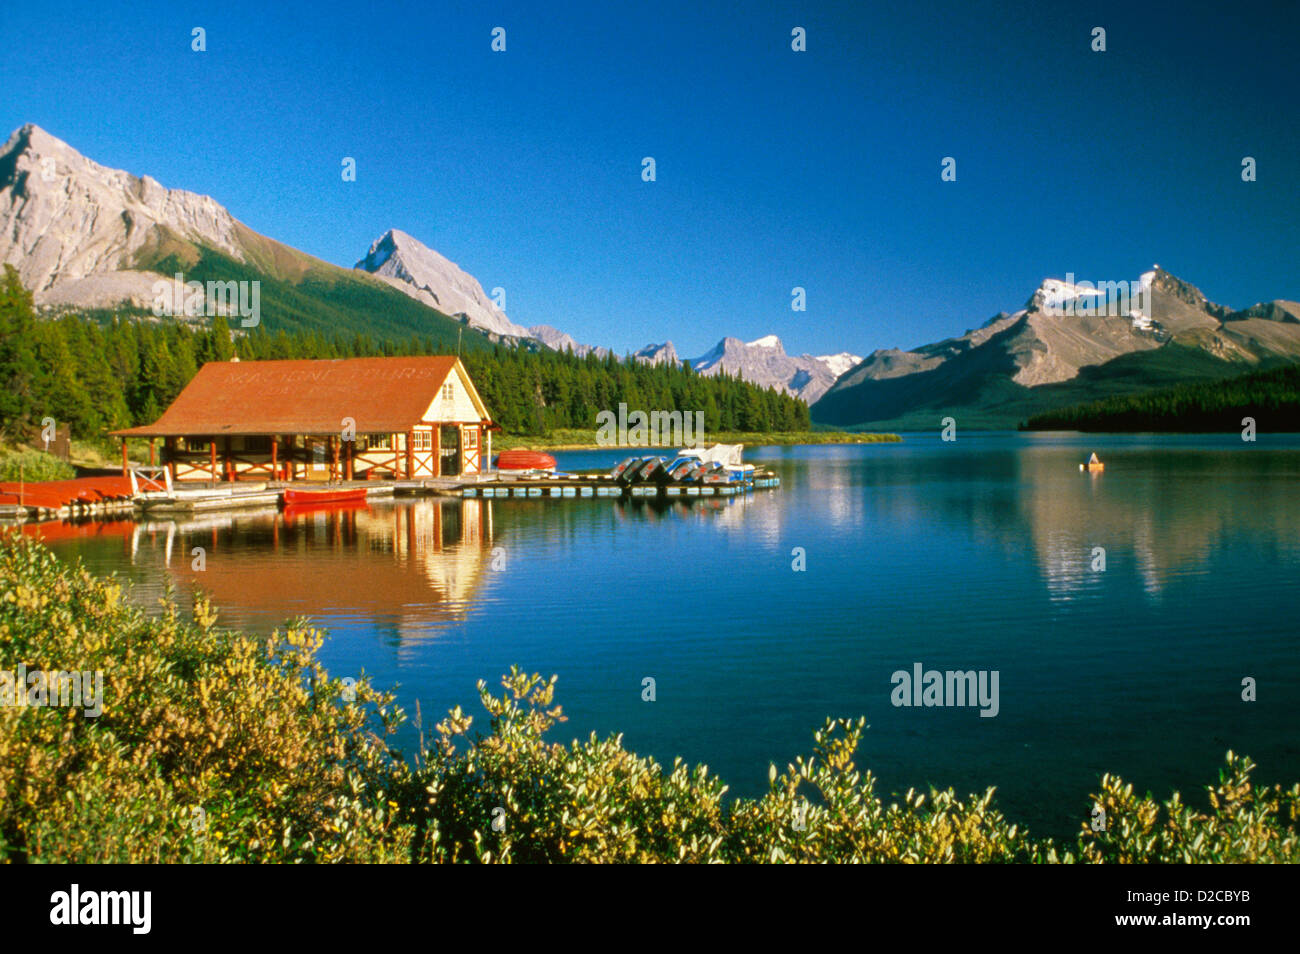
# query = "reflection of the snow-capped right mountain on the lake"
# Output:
<box><xmin>853</xmin><ymin>447</ymin><xmax>1300</xmax><ymax>599</ymax></box>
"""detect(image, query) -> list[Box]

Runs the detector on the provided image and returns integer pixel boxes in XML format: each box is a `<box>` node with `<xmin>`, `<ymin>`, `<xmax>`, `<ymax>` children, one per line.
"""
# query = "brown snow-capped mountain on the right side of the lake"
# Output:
<box><xmin>811</xmin><ymin>265</ymin><xmax>1300</xmax><ymax>429</ymax></box>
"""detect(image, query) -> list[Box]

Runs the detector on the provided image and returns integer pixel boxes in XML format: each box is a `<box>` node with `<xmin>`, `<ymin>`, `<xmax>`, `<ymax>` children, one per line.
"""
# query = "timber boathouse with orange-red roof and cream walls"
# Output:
<box><xmin>112</xmin><ymin>356</ymin><xmax>495</xmax><ymax>481</ymax></box>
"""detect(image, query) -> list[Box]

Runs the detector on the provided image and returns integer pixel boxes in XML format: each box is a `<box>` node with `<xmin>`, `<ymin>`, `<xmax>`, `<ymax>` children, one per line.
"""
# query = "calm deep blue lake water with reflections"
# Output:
<box><xmin>35</xmin><ymin>434</ymin><xmax>1300</xmax><ymax>836</ymax></box>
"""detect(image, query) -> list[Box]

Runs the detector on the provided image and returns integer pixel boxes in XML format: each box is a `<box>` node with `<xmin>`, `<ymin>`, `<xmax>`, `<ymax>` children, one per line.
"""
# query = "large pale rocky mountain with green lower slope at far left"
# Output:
<box><xmin>0</xmin><ymin>125</ymin><xmax>488</xmax><ymax>348</ymax></box>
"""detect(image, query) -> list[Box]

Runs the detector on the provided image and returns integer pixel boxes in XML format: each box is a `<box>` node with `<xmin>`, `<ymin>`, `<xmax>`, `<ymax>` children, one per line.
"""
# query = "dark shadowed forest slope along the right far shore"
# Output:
<box><xmin>1024</xmin><ymin>365</ymin><xmax>1300</xmax><ymax>433</ymax></box>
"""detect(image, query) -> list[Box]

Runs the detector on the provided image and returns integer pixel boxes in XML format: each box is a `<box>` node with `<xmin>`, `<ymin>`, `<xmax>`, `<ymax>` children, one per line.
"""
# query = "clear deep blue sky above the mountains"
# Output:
<box><xmin>0</xmin><ymin>0</ymin><xmax>1300</xmax><ymax>356</ymax></box>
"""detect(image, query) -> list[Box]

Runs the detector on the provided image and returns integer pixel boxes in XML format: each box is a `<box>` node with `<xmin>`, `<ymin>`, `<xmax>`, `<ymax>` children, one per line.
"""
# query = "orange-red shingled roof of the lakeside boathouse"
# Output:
<box><xmin>112</xmin><ymin>355</ymin><xmax>488</xmax><ymax>437</ymax></box>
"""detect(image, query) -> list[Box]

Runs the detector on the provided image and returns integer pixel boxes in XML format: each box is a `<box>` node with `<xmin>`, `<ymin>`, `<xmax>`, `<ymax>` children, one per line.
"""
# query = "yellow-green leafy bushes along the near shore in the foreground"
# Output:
<box><xmin>0</xmin><ymin>534</ymin><xmax>1300</xmax><ymax>862</ymax></box>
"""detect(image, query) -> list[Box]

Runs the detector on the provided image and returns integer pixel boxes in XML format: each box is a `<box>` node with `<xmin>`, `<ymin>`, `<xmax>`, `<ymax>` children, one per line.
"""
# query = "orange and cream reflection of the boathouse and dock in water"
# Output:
<box><xmin>22</xmin><ymin>498</ymin><xmax>764</xmax><ymax>645</ymax></box>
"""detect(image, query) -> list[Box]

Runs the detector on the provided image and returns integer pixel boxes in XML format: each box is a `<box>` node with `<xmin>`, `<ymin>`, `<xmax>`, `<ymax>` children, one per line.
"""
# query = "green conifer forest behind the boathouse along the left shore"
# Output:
<box><xmin>0</xmin><ymin>266</ymin><xmax>809</xmax><ymax>441</ymax></box>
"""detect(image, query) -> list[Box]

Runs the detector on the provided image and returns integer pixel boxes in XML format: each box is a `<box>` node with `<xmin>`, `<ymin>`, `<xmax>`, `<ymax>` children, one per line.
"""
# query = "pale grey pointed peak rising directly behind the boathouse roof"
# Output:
<box><xmin>354</xmin><ymin>229</ymin><xmax>533</xmax><ymax>338</ymax></box>
